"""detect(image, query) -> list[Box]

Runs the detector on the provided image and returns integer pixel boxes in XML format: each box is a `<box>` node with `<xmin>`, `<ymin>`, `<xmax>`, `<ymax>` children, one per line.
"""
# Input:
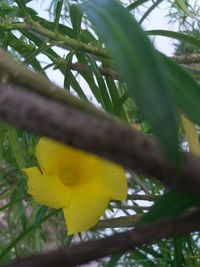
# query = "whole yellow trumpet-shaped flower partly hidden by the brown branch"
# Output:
<box><xmin>24</xmin><ymin>137</ymin><xmax>127</xmax><ymax>234</ymax></box>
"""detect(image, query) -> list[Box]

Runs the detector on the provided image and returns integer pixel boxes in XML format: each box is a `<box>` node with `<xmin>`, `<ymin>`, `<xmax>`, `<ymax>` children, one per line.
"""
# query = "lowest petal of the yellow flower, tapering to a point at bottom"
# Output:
<box><xmin>63</xmin><ymin>184</ymin><xmax>110</xmax><ymax>234</ymax></box>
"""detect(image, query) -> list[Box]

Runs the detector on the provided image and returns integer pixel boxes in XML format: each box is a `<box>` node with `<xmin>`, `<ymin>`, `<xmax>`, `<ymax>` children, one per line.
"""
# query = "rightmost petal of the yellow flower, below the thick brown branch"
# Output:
<box><xmin>87</xmin><ymin>158</ymin><xmax>127</xmax><ymax>200</ymax></box>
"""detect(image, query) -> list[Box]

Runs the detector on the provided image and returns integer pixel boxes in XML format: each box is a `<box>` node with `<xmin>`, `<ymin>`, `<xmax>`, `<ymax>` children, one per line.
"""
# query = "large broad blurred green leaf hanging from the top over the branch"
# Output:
<box><xmin>82</xmin><ymin>0</ymin><xmax>179</xmax><ymax>160</ymax></box>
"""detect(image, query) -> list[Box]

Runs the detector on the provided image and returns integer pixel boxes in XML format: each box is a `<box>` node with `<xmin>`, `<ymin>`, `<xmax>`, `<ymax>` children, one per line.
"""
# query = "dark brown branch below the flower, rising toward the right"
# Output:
<box><xmin>2</xmin><ymin>210</ymin><xmax>200</xmax><ymax>267</ymax></box>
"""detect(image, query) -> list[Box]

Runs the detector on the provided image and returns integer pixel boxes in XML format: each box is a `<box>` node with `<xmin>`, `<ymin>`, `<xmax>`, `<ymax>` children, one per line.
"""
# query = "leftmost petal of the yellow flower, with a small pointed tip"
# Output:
<box><xmin>23</xmin><ymin>167</ymin><xmax>72</xmax><ymax>208</ymax></box>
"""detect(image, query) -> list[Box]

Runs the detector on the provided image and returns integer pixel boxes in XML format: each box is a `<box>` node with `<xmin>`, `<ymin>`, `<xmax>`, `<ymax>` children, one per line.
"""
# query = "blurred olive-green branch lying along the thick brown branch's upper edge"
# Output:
<box><xmin>0</xmin><ymin>50</ymin><xmax>113</xmax><ymax>120</ymax></box>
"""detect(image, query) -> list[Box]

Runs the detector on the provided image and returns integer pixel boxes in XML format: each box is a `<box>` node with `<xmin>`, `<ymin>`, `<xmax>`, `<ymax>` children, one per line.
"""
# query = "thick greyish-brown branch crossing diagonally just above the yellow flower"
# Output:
<box><xmin>0</xmin><ymin>86</ymin><xmax>200</xmax><ymax>195</ymax></box>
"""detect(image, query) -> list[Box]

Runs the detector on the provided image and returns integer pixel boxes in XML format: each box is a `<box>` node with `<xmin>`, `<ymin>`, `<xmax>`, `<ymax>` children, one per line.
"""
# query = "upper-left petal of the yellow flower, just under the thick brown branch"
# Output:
<box><xmin>36</xmin><ymin>137</ymin><xmax>91</xmax><ymax>174</ymax></box>
